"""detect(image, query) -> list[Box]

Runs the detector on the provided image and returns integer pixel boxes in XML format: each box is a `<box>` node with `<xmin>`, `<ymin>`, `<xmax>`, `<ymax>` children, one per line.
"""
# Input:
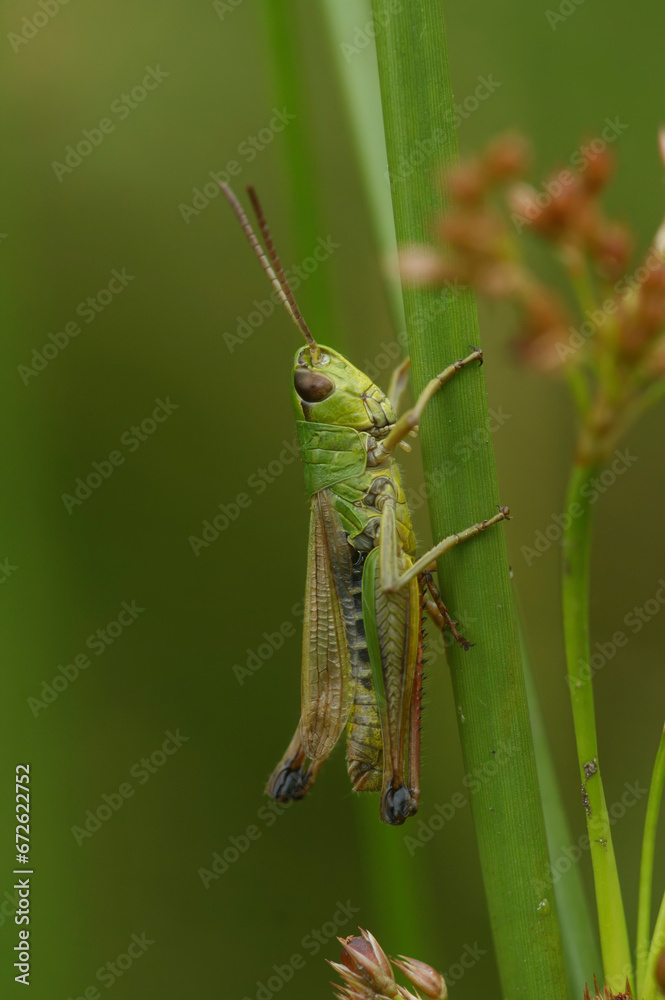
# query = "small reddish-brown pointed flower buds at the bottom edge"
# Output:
<box><xmin>329</xmin><ymin>930</ymin><xmax>448</xmax><ymax>1000</ymax></box>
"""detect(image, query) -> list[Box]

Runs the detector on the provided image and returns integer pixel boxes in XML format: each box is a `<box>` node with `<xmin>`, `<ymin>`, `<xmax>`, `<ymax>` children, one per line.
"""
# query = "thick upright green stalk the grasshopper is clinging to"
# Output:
<box><xmin>373</xmin><ymin>0</ymin><xmax>566</xmax><ymax>1000</ymax></box>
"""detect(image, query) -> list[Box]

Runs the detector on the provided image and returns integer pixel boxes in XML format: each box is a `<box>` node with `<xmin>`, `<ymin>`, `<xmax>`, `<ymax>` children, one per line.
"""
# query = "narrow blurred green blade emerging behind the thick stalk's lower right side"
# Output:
<box><xmin>518</xmin><ymin>616</ymin><xmax>602</xmax><ymax>1000</ymax></box>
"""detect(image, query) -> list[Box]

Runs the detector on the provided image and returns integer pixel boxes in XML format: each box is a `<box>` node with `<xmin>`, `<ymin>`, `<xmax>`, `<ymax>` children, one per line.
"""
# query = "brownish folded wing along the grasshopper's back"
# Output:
<box><xmin>301</xmin><ymin>490</ymin><xmax>355</xmax><ymax>760</ymax></box>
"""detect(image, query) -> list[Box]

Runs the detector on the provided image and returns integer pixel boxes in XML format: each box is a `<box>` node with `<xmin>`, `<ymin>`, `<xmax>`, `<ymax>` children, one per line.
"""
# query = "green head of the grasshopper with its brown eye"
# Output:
<box><xmin>293</xmin><ymin>345</ymin><xmax>396</xmax><ymax>437</ymax></box>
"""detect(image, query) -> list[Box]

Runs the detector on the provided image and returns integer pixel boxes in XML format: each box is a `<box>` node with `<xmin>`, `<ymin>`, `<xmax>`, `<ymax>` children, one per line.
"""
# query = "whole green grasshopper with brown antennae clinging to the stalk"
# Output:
<box><xmin>222</xmin><ymin>184</ymin><xmax>510</xmax><ymax>825</ymax></box>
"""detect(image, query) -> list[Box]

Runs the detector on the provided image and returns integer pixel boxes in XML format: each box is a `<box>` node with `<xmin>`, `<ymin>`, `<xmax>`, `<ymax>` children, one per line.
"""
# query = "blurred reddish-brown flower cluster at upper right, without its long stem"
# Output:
<box><xmin>401</xmin><ymin>134</ymin><xmax>665</xmax><ymax>459</ymax></box>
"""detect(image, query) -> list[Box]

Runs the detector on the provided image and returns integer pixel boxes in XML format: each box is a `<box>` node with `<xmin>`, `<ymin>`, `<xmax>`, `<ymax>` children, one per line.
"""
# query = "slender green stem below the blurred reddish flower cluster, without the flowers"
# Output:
<box><xmin>563</xmin><ymin>460</ymin><xmax>632</xmax><ymax>990</ymax></box>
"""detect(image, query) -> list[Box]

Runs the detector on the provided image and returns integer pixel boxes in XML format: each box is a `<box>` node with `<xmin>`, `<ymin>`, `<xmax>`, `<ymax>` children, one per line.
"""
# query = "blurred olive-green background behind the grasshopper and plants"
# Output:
<box><xmin>0</xmin><ymin>0</ymin><xmax>665</xmax><ymax>1000</ymax></box>
